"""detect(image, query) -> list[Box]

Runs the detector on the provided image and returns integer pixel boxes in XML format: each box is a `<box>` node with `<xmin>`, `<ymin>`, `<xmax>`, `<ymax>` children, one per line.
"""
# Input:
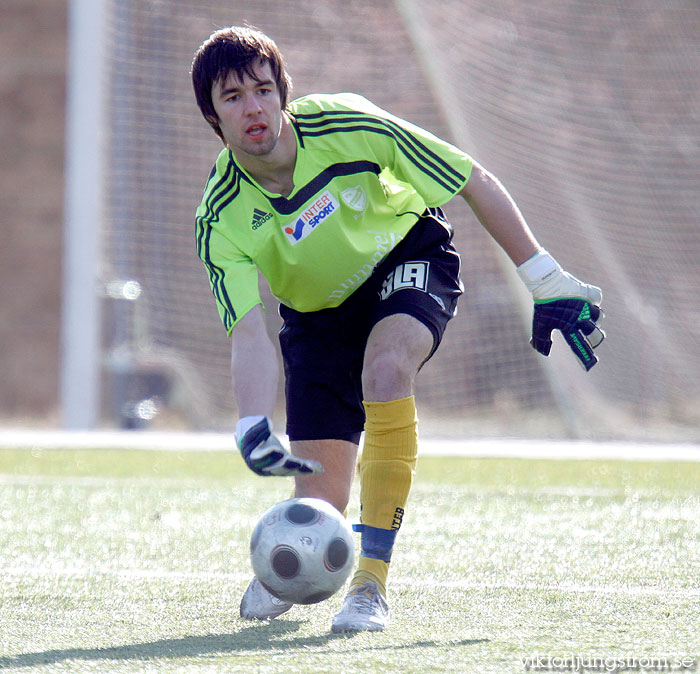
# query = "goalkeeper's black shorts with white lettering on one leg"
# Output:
<box><xmin>280</xmin><ymin>208</ymin><xmax>463</xmax><ymax>444</ymax></box>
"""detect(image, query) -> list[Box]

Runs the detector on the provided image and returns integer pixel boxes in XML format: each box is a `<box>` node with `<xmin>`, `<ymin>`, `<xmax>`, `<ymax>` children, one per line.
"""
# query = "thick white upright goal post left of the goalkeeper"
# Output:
<box><xmin>60</xmin><ymin>0</ymin><xmax>105</xmax><ymax>430</ymax></box>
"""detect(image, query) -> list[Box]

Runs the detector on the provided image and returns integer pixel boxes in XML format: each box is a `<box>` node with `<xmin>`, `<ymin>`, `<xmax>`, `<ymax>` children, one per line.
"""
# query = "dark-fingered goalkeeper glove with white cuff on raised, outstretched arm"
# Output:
<box><xmin>517</xmin><ymin>250</ymin><xmax>605</xmax><ymax>371</ymax></box>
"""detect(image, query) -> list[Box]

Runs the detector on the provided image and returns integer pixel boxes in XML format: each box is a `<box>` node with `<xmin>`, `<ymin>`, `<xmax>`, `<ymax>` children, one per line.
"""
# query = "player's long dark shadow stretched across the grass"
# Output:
<box><xmin>0</xmin><ymin>618</ymin><xmax>488</xmax><ymax>670</ymax></box>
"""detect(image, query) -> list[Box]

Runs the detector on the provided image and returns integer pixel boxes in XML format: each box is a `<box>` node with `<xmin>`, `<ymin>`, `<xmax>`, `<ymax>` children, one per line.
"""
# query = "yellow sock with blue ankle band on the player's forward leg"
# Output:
<box><xmin>352</xmin><ymin>396</ymin><xmax>418</xmax><ymax>596</ymax></box>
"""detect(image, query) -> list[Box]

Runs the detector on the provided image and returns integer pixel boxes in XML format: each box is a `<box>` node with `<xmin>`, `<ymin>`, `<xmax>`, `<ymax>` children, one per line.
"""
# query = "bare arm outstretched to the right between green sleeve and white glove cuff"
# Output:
<box><xmin>460</xmin><ymin>164</ymin><xmax>540</xmax><ymax>266</ymax></box>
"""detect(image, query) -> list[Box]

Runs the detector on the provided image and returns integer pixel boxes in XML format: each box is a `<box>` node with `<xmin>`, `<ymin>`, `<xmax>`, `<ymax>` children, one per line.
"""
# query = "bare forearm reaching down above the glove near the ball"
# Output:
<box><xmin>231</xmin><ymin>307</ymin><xmax>279</xmax><ymax>418</ymax></box>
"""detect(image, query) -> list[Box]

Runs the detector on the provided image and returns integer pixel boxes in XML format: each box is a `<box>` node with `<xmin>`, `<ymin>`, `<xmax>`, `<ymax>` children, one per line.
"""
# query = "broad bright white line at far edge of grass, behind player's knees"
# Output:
<box><xmin>0</xmin><ymin>428</ymin><xmax>700</xmax><ymax>461</ymax></box>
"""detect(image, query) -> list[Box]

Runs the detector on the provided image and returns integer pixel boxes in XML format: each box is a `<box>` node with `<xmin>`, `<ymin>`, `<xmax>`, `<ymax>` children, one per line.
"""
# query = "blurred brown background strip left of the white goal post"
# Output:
<box><xmin>0</xmin><ymin>0</ymin><xmax>67</xmax><ymax>423</ymax></box>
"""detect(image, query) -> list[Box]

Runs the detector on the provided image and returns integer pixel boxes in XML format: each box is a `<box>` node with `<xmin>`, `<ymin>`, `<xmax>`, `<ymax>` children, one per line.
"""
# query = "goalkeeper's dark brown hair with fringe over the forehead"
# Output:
<box><xmin>192</xmin><ymin>26</ymin><xmax>292</xmax><ymax>140</ymax></box>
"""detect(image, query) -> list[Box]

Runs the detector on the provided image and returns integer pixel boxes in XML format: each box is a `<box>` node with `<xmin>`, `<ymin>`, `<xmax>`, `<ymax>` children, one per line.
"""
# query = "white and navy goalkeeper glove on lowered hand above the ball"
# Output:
<box><xmin>236</xmin><ymin>415</ymin><xmax>323</xmax><ymax>476</ymax></box>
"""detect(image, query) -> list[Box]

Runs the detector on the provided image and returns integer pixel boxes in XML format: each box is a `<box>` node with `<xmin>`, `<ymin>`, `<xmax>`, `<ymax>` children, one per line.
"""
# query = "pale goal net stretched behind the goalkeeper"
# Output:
<box><xmin>90</xmin><ymin>0</ymin><xmax>700</xmax><ymax>440</ymax></box>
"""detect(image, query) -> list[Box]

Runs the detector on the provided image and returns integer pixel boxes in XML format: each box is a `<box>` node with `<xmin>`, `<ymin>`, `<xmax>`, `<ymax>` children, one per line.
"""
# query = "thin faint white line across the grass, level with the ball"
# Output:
<box><xmin>0</xmin><ymin>566</ymin><xmax>700</xmax><ymax>599</ymax></box>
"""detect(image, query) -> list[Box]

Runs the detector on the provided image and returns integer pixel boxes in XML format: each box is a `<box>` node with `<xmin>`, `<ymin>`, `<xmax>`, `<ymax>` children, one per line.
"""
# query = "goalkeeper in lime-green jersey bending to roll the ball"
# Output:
<box><xmin>192</xmin><ymin>27</ymin><xmax>604</xmax><ymax>632</ymax></box>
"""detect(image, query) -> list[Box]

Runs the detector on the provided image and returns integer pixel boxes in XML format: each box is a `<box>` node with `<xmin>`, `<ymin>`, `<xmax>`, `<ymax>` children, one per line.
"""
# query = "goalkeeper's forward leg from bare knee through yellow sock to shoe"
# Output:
<box><xmin>332</xmin><ymin>314</ymin><xmax>433</xmax><ymax>632</ymax></box>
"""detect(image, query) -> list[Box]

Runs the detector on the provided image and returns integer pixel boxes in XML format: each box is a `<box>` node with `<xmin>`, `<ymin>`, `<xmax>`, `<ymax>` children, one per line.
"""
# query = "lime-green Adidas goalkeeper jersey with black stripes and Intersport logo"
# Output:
<box><xmin>196</xmin><ymin>94</ymin><xmax>472</xmax><ymax>334</ymax></box>
